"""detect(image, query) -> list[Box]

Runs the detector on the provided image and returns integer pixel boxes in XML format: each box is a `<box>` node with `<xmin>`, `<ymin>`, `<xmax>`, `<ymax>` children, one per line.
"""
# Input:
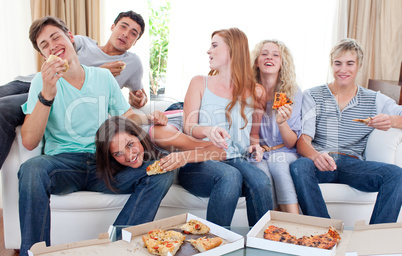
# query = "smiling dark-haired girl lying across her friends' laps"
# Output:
<box><xmin>95</xmin><ymin>116</ymin><xmax>223</xmax><ymax>190</ymax></box>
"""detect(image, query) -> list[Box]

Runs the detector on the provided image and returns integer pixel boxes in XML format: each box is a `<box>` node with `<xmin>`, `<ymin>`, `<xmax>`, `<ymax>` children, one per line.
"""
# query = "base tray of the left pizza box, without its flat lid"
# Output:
<box><xmin>121</xmin><ymin>213</ymin><xmax>244</xmax><ymax>256</ymax></box>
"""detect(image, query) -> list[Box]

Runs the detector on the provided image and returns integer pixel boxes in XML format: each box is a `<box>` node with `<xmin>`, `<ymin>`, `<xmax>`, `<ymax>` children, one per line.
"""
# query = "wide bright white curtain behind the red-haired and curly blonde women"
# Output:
<box><xmin>166</xmin><ymin>0</ymin><xmax>344</xmax><ymax>101</ymax></box>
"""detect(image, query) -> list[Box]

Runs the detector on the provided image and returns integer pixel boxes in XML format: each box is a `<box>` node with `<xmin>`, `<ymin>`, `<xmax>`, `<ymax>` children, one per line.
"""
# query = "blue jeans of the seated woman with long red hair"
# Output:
<box><xmin>179</xmin><ymin>158</ymin><xmax>273</xmax><ymax>226</ymax></box>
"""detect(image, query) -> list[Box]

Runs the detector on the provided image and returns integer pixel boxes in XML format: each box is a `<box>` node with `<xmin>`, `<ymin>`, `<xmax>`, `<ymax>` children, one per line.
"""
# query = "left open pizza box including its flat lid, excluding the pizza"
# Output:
<box><xmin>28</xmin><ymin>214</ymin><xmax>244</xmax><ymax>256</ymax></box>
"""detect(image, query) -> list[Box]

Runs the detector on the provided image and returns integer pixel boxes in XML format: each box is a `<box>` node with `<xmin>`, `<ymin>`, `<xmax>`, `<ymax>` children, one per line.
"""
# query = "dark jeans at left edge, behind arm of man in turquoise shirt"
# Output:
<box><xmin>0</xmin><ymin>81</ymin><xmax>31</xmax><ymax>168</ymax></box>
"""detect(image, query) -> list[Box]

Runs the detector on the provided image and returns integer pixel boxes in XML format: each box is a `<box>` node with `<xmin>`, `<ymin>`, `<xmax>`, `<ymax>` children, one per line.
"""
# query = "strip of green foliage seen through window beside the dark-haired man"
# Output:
<box><xmin>148</xmin><ymin>0</ymin><xmax>170</xmax><ymax>95</ymax></box>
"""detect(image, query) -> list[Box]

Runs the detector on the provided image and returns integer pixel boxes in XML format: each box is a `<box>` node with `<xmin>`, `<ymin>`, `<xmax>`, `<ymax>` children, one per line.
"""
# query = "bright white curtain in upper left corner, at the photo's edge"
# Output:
<box><xmin>0</xmin><ymin>0</ymin><xmax>36</xmax><ymax>85</ymax></box>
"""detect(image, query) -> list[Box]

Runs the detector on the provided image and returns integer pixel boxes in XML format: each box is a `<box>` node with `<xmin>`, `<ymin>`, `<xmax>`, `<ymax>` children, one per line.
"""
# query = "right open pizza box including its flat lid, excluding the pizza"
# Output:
<box><xmin>246</xmin><ymin>211</ymin><xmax>402</xmax><ymax>256</ymax></box>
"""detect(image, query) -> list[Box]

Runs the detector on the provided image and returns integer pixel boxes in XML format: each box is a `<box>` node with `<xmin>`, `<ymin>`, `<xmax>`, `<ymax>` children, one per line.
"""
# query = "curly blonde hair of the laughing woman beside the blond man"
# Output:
<box><xmin>251</xmin><ymin>40</ymin><xmax>298</xmax><ymax>100</ymax></box>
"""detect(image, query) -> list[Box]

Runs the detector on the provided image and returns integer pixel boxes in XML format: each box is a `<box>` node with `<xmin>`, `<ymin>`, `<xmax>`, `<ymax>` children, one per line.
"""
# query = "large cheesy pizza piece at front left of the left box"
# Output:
<box><xmin>142</xmin><ymin>229</ymin><xmax>186</xmax><ymax>256</ymax></box>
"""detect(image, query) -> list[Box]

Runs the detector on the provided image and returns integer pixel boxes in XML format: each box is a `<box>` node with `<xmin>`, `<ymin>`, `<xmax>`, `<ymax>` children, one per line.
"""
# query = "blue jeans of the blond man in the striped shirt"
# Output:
<box><xmin>290</xmin><ymin>154</ymin><xmax>402</xmax><ymax>224</ymax></box>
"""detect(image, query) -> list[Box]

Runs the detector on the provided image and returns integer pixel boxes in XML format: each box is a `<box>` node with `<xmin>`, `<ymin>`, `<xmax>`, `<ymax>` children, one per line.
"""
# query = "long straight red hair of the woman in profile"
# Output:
<box><xmin>208</xmin><ymin>28</ymin><xmax>257</xmax><ymax>129</ymax></box>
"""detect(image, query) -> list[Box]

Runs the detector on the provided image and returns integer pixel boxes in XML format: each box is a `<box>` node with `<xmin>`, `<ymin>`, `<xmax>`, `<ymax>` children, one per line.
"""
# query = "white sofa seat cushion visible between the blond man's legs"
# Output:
<box><xmin>320</xmin><ymin>183</ymin><xmax>377</xmax><ymax>204</ymax></box>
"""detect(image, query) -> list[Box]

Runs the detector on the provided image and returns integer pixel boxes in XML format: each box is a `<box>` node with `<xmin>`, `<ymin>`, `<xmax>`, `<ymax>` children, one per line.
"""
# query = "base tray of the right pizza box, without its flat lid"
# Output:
<box><xmin>246</xmin><ymin>211</ymin><xmax>343</xmax><ymax>256</ymax></box>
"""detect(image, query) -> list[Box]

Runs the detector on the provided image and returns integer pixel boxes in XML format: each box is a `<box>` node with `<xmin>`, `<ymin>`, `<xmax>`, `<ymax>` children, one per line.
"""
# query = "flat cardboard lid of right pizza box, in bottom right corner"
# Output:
<box><xmin>345</xmin><ymin>221</ymin><xmax>402</xmax><ymax>256</ymax></box>
